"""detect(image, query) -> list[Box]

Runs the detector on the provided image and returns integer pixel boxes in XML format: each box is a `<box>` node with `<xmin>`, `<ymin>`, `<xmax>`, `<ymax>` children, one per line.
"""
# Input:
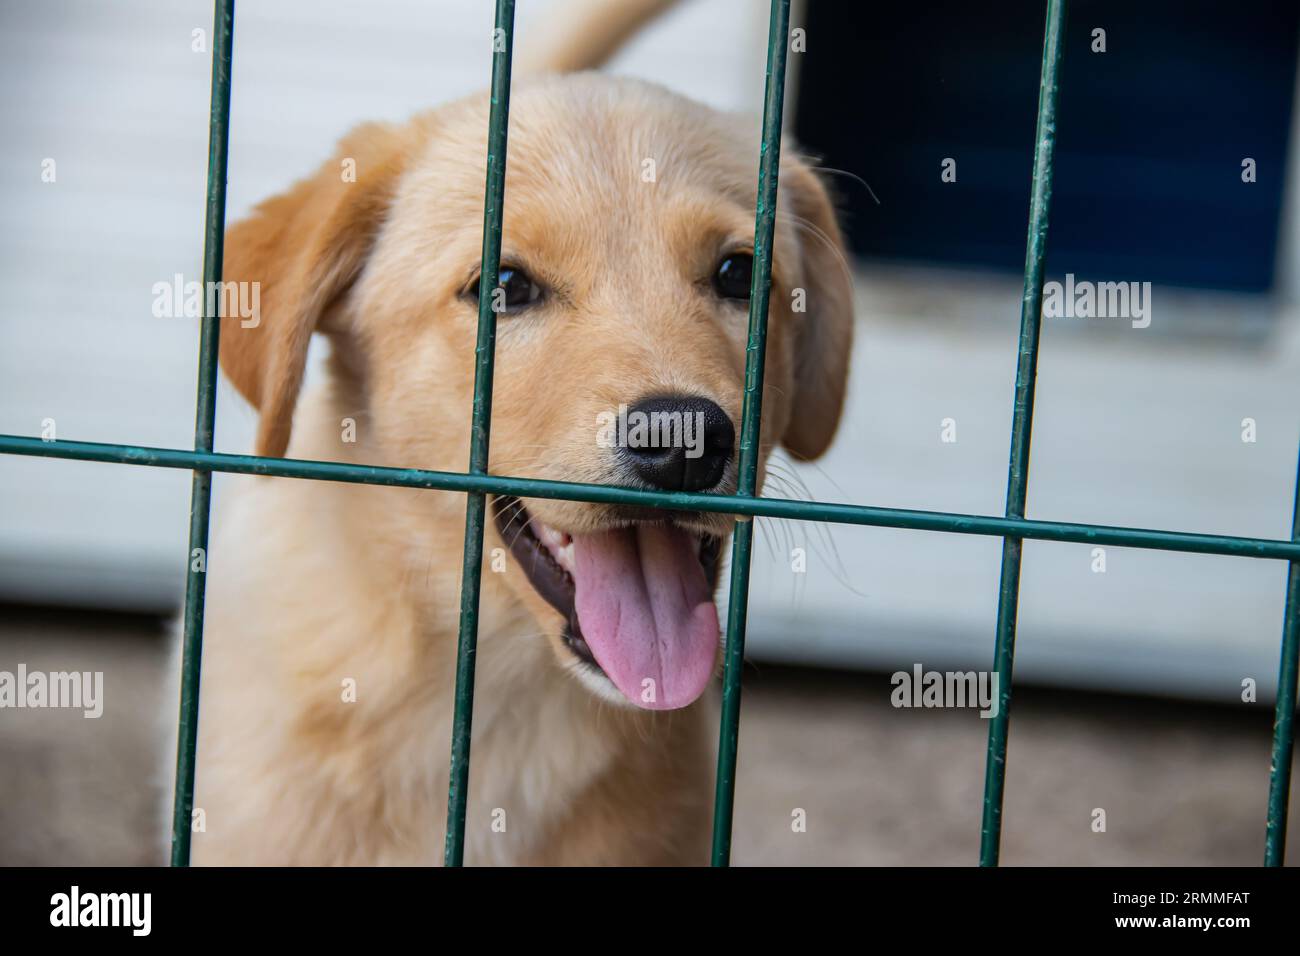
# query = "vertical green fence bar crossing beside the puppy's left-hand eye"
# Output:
<box><xmin>443</xmin><ymin>0</ymin><xmax>515</xmax><ymax>866</ymax></box>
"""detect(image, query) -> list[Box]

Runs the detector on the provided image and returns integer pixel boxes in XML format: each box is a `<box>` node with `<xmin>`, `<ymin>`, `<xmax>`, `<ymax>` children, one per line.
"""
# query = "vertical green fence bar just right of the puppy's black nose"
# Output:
<box><xmin>712</xmin><ymin>0</ymin><xmax>790</xmax><ymax>866</ymax></box>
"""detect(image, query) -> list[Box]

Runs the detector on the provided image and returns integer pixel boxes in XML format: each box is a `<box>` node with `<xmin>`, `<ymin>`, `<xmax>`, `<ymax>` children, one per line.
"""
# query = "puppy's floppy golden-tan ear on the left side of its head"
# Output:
<box><xmin>221</xmin><ymin>124</ymin><xmax>412</xmax><ymax>457</ymax></box>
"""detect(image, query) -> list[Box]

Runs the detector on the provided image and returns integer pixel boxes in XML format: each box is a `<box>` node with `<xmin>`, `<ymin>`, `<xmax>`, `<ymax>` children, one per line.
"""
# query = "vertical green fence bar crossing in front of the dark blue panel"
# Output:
<box><xmin>980</xmin><ymin>0</ymin><xmax>1065</xmax><ymax>866</ymax></box>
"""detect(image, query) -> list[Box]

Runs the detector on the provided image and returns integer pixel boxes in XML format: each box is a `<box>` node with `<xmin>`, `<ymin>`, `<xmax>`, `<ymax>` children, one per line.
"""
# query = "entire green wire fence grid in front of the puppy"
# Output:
<box><xmin>0</xmin><ymin>0</ymin><xmax>1300</xmax><ymax>866</ymax></box>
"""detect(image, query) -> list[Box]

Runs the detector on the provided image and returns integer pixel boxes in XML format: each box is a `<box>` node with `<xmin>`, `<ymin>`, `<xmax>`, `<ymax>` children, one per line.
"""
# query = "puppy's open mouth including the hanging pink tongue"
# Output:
<box><xmin>491</xmin><ymin>497</ymin><xmax>722</xmax><ymax>710</ymax></box>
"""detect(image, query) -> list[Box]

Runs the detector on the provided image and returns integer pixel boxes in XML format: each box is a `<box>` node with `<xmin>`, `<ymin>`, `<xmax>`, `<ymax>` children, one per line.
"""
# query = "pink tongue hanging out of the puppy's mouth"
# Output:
<box><xmin>573</xmin><ymin>524</ymin><xmax>718</xmax><ymax>710</ymax></box>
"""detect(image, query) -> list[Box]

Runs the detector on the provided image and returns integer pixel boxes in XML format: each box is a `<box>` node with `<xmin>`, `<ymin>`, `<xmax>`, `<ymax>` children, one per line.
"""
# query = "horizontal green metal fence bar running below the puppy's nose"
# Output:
<box><xmin>0</xmin><ymin>434</ymin><xmax>1300</xmax><ymax>561</ymax></box>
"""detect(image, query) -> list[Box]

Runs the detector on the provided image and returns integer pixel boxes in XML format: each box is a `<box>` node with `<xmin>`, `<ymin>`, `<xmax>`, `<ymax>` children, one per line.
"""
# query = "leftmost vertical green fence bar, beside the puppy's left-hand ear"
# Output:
<box><xmin>172</xmin><ymin>0</ymin><xmax>235</xmax><ymax>866</ymax></box>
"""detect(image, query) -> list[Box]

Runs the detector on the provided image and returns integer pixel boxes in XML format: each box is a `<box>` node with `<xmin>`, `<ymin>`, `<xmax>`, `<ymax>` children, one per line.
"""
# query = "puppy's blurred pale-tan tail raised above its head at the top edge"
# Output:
<box><xmin>515</xmin><ymin>0</ymin><xmax>677</xmax><ymax>73</ymax></box>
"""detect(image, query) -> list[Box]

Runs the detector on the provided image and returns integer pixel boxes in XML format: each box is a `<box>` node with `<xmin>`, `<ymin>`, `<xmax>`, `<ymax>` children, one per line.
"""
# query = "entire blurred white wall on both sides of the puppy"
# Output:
<box><xmin>0</xmin><ymin>0</ymin><xmax>1300</xmax><ymax>698</ymax></box>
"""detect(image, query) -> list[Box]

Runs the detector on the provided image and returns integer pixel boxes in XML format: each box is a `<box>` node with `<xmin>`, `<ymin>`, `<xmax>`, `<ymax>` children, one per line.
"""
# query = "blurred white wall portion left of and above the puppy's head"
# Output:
<box><xmin>0</xmin><ymin>0</ymin><xmax>766</xmax><ymax>606</ymax></box>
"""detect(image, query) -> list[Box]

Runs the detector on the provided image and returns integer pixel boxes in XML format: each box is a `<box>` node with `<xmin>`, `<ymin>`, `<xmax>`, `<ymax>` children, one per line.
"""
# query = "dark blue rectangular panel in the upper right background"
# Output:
<box><xmin>796</xmin><ymin>0</ymin><xmax>1300</xmax><ymax>290</ymax></box>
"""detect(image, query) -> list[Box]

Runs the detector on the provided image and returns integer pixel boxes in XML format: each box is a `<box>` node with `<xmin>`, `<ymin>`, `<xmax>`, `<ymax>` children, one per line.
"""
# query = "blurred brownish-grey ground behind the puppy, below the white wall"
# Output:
<box><xmin>0</xmin><ymin>606</ymin><xmax>1300</xmax><ymax>865</ymax></box>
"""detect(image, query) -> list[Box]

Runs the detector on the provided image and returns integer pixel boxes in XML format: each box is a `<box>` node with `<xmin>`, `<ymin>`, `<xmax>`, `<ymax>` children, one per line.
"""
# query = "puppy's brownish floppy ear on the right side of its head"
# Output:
<box><xmin>780</xmin><ymin>160</ymin><xmax>853</xmax><ymax>459</ymax></box>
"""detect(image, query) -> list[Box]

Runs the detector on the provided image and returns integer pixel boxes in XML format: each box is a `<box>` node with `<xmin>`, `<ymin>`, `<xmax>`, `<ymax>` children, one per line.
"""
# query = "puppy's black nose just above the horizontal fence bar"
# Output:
<box><xmin>619</xmin><ymin>395</ymin><xmax>736</xmax><ymax>492</ymax></box>
